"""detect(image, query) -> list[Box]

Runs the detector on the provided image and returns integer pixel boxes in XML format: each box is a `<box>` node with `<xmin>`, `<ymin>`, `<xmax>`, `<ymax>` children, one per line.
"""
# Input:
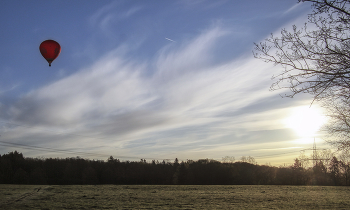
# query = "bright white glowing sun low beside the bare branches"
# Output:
<box><xmin>285</xmin><ymin>106</ymin><xmax>326</xmax><ymax>137</ymax></box>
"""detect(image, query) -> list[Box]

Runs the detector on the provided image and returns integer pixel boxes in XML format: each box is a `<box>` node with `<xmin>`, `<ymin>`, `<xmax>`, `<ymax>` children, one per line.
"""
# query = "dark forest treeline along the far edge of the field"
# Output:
<box><xmin>0</xmin><ymin>151</ymin><xmax>350</xmax><ymax>186</ymax></box>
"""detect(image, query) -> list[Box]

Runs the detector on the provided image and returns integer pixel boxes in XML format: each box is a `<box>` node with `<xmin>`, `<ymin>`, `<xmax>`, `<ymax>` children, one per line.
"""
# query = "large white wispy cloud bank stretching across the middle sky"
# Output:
<box><xmin>3</xmin><ymin>27</ymin><xmax>308</xmax><ymax>162</ymax></box>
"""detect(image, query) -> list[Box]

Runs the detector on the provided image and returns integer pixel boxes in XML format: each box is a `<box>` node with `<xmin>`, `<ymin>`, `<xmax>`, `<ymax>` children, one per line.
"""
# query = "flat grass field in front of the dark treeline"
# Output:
<box><xmin>0</xmin><ymin>185</ymin><xmax>350</xmax><ymax>209</ymax></box>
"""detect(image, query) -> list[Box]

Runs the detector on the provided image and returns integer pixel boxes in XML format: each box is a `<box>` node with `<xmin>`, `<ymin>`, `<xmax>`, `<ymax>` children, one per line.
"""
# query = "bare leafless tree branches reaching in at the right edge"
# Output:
<box><xmin>253</xmin><ymin>0</ymin><xmax>350</xmax><ymax>150</ymax></box>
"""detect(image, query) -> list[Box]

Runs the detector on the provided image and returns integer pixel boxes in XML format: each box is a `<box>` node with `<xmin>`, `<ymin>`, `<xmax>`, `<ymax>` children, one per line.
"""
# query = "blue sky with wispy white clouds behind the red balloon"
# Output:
<box><xmin>0</xmin><ymin>0</ymin><xmax>327</xmax><ymax>166</ymax></box>
